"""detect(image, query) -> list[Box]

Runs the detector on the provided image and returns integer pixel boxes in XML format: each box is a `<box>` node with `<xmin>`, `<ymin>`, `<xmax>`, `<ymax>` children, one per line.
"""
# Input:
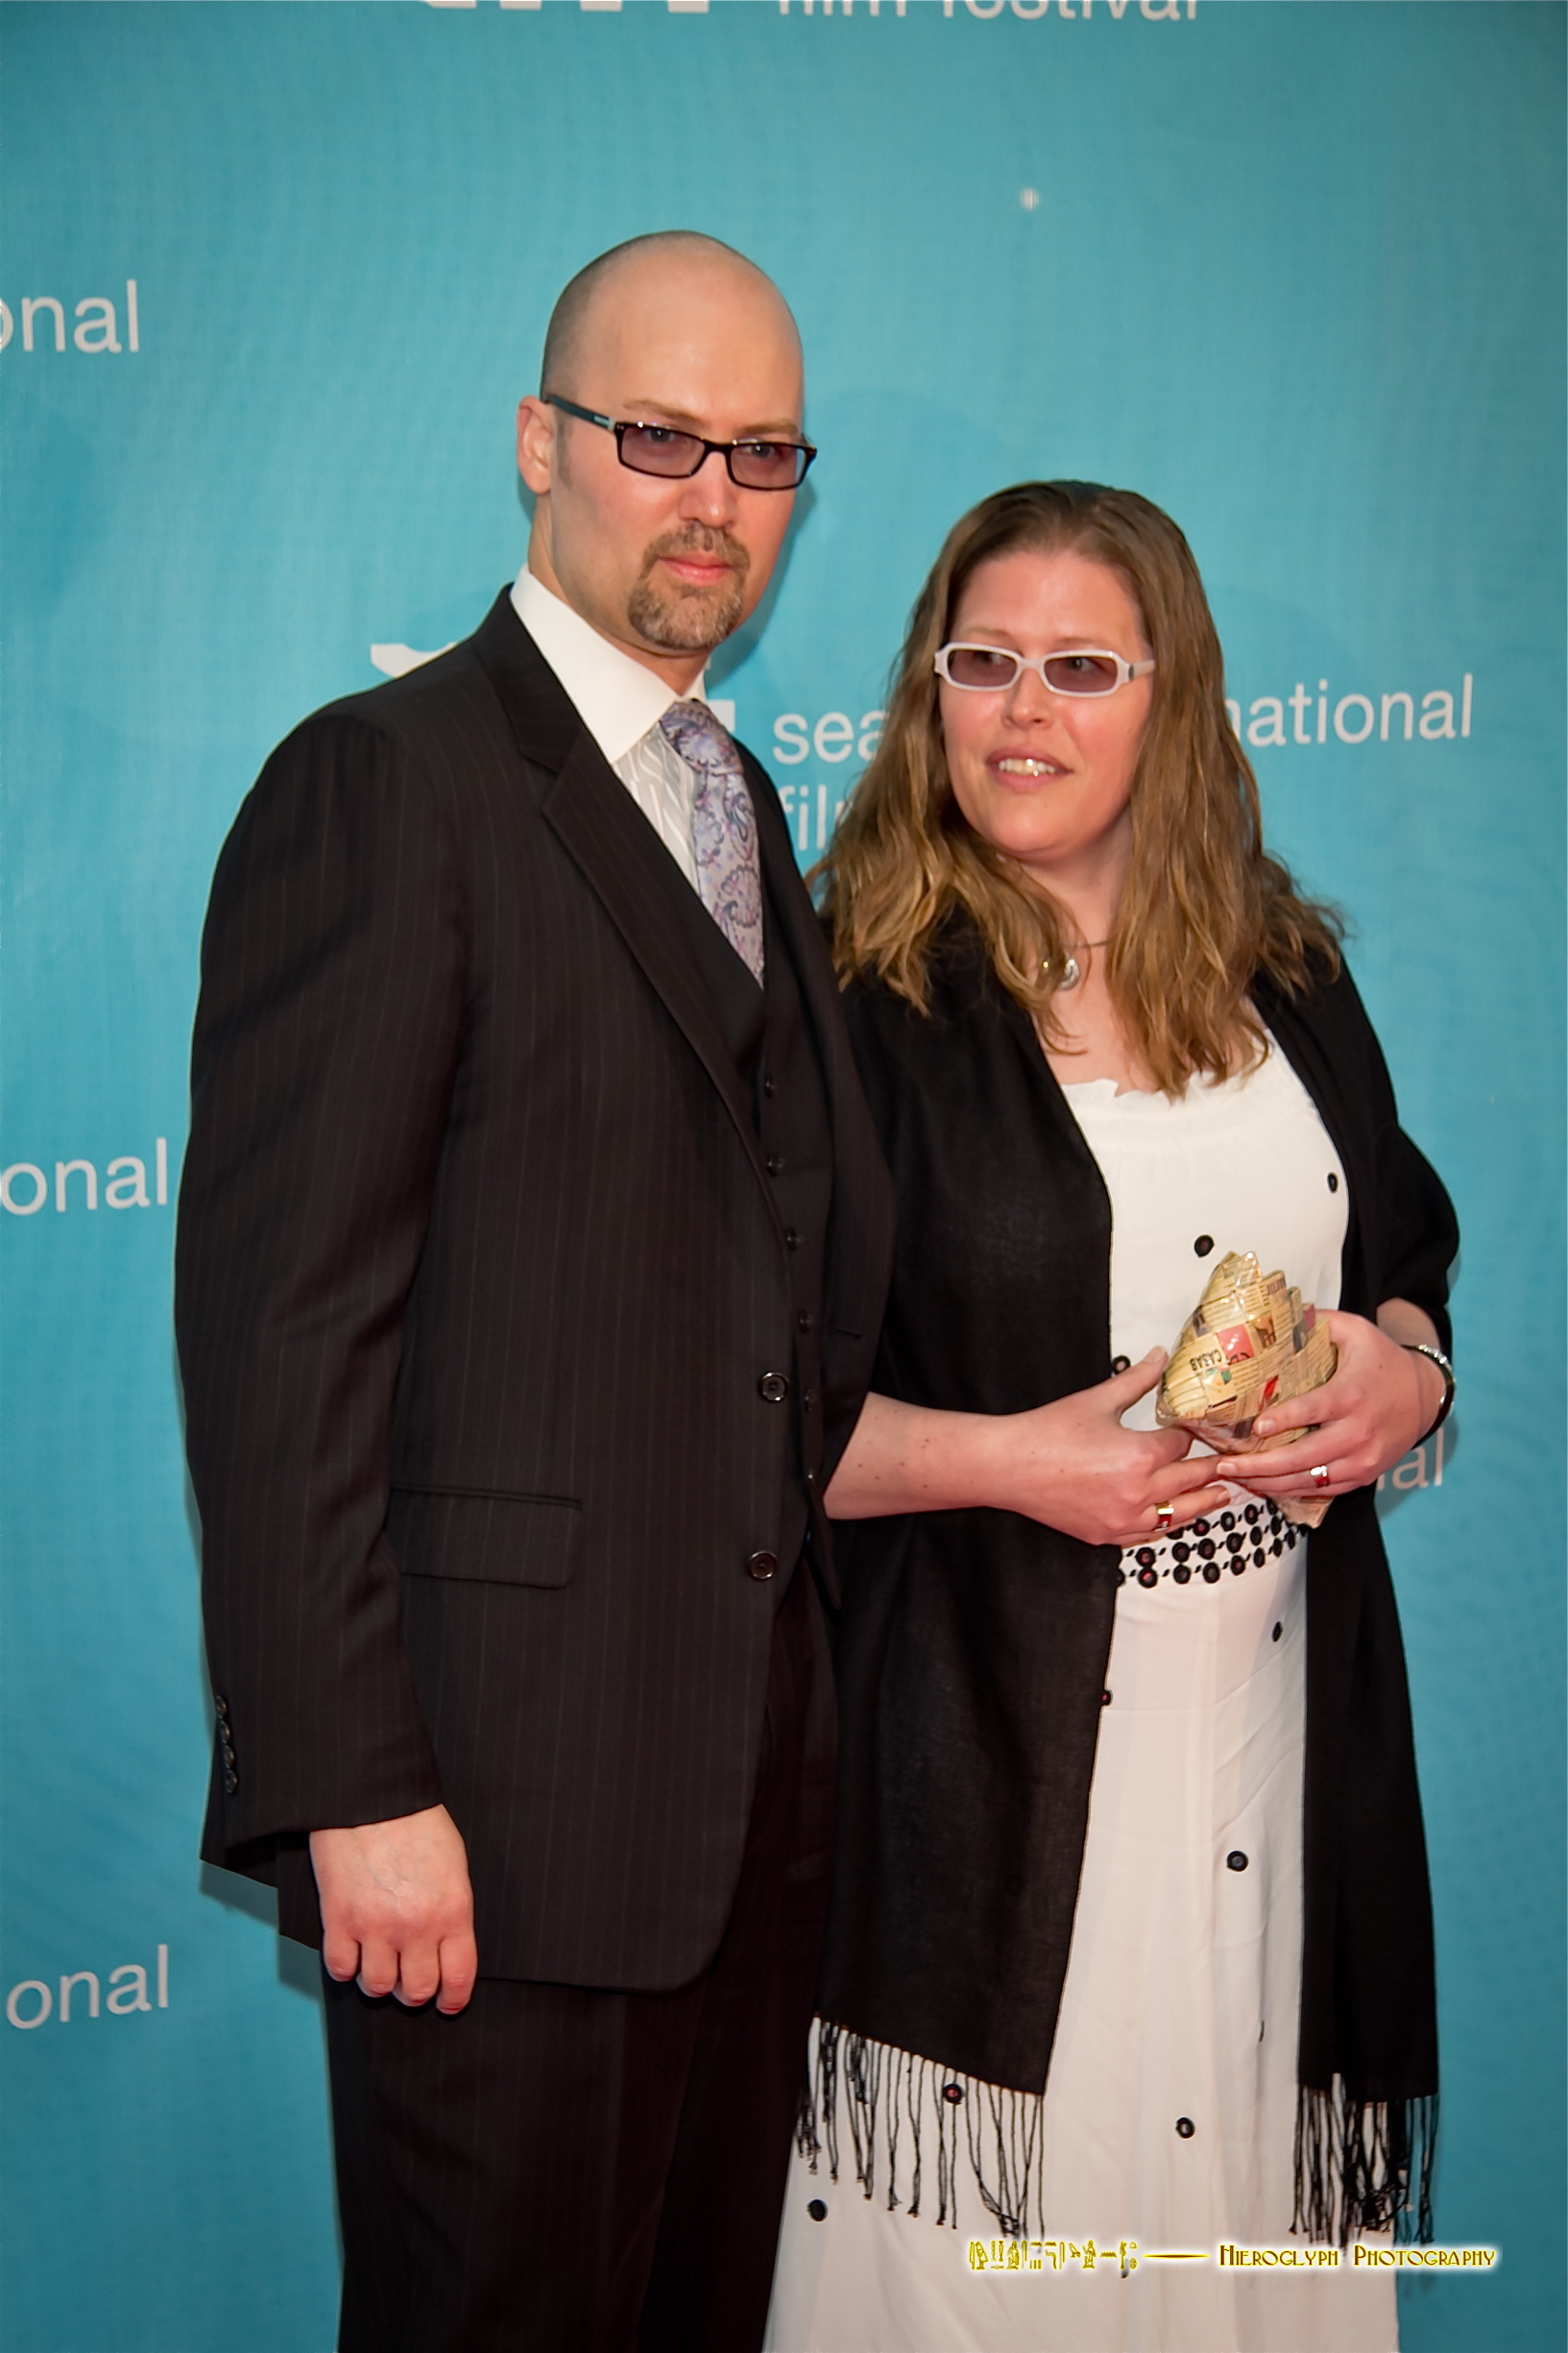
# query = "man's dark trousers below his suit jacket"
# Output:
<box><xmin>326</xmin><ymin>1563</ymin><xmax>834</xmax><ymax>2353</ymax></box>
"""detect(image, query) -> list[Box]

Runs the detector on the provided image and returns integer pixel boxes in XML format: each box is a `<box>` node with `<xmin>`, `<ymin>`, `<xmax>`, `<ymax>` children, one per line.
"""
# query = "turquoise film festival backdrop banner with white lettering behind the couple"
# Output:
<box><xmin>0</xmin><ymin>0</ymin><xmax>1566</xmax><ymax>2353</ymax></box>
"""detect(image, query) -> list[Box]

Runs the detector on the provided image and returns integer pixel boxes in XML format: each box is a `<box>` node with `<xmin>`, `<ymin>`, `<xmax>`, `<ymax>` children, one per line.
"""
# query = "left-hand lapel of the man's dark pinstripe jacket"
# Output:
<box><xmin>475</xmin><ymin>591</ymin><xmax>778</xmax><ymax>1219</ymax></box>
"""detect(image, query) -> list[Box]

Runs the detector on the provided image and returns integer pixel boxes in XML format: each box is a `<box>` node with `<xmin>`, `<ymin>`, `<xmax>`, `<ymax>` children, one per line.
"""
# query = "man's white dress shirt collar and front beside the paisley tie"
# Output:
<box><xmin>513</xmin><ymin>565</ymin><xmax>708</xmax><ymax>889</ymax></box>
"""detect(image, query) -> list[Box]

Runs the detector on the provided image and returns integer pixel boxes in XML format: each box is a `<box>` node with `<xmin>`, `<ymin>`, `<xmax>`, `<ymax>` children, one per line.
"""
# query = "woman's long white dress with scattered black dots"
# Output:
<box><xmin>766</xmin><ymin>1047</ymin><xmax>1399</xmax><ymax>2353</ymax></box>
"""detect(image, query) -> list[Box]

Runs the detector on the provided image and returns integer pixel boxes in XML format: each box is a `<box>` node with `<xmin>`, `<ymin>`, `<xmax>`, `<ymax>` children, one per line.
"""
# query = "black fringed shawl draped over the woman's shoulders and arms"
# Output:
<box><xmin>818</xmin><ymin>925</ymin><xmax>1458</xmax><ymax>2238</ymax></box>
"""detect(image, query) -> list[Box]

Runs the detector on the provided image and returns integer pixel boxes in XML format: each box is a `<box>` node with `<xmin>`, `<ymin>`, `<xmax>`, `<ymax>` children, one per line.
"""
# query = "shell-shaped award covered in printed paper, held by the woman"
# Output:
<box><xmin>1154</xmin><ymin>1249</ymin><xmax>1338</xmax><ymax>1527</ymax></box>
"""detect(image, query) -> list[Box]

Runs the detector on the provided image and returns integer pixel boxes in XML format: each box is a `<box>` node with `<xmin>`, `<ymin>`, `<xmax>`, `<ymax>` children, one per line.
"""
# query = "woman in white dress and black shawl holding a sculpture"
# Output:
<box><xmin>769</xmin><ymin>482</ymin><xmax>1455</xmax><ymax>2353</ymax></box>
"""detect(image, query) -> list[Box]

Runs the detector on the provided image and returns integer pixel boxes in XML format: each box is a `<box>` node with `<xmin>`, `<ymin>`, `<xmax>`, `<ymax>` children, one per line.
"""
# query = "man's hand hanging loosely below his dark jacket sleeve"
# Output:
<box><xmin>310</xmin><ymin>1805</ymin><xmax>479</xmax><ymax>2017</ymax></box>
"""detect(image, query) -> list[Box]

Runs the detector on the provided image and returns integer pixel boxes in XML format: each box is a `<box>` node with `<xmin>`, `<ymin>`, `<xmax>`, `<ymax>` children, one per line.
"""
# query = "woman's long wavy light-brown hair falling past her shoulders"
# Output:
<box><xmin>813</xmin><ymin>482</ymin><xmax>1342</xmax><ymax>1097</ymax></box>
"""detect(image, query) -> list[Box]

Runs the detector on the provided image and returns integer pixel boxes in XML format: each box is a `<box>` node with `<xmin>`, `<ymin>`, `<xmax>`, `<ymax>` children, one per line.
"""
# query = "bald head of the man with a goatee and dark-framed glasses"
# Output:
<box><xmin>518</xmin><ymin>230</ymin><xmax>804</xmax><ymax>694</ymax></box>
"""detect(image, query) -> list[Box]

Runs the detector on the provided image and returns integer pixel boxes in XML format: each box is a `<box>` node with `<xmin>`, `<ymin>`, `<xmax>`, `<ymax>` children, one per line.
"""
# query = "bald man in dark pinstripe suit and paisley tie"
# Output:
<box><xmin>177</xmin><ymin>235</ymin><xmax>891</xmax><ymax>2353</ymax></box>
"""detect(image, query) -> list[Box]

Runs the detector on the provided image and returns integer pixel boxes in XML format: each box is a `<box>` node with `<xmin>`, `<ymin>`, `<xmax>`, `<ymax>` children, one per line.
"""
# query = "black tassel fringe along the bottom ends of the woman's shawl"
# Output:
<box><xmin>795</xmin><ymin>2022</ymin><xmax>1436</xmax><ymax>2247</ymax></box>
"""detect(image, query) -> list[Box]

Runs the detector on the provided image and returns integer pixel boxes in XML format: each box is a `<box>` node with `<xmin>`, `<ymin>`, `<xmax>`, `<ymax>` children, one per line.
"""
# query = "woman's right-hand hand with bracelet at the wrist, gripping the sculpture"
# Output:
<box><xmin>1216</xmin><ymin>1298</ymin><xmax>1446</xmax><ymax>1496</ymax></box>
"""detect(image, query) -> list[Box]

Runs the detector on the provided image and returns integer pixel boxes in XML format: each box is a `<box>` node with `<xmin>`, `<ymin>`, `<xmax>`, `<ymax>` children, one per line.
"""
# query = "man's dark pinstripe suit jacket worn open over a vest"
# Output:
<box><xmin>177</xmin><ymin>595</ymin><xmax>891</xmax><ymax>1988</ymax></box>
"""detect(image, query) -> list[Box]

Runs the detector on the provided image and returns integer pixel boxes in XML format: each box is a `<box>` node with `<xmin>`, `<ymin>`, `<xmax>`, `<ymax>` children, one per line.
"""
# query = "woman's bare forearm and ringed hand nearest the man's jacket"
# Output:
<box><xmin>825</xmin><ymin>1348</ymin><xmax>1227</xmax><ymax>1543</ymax></box>
